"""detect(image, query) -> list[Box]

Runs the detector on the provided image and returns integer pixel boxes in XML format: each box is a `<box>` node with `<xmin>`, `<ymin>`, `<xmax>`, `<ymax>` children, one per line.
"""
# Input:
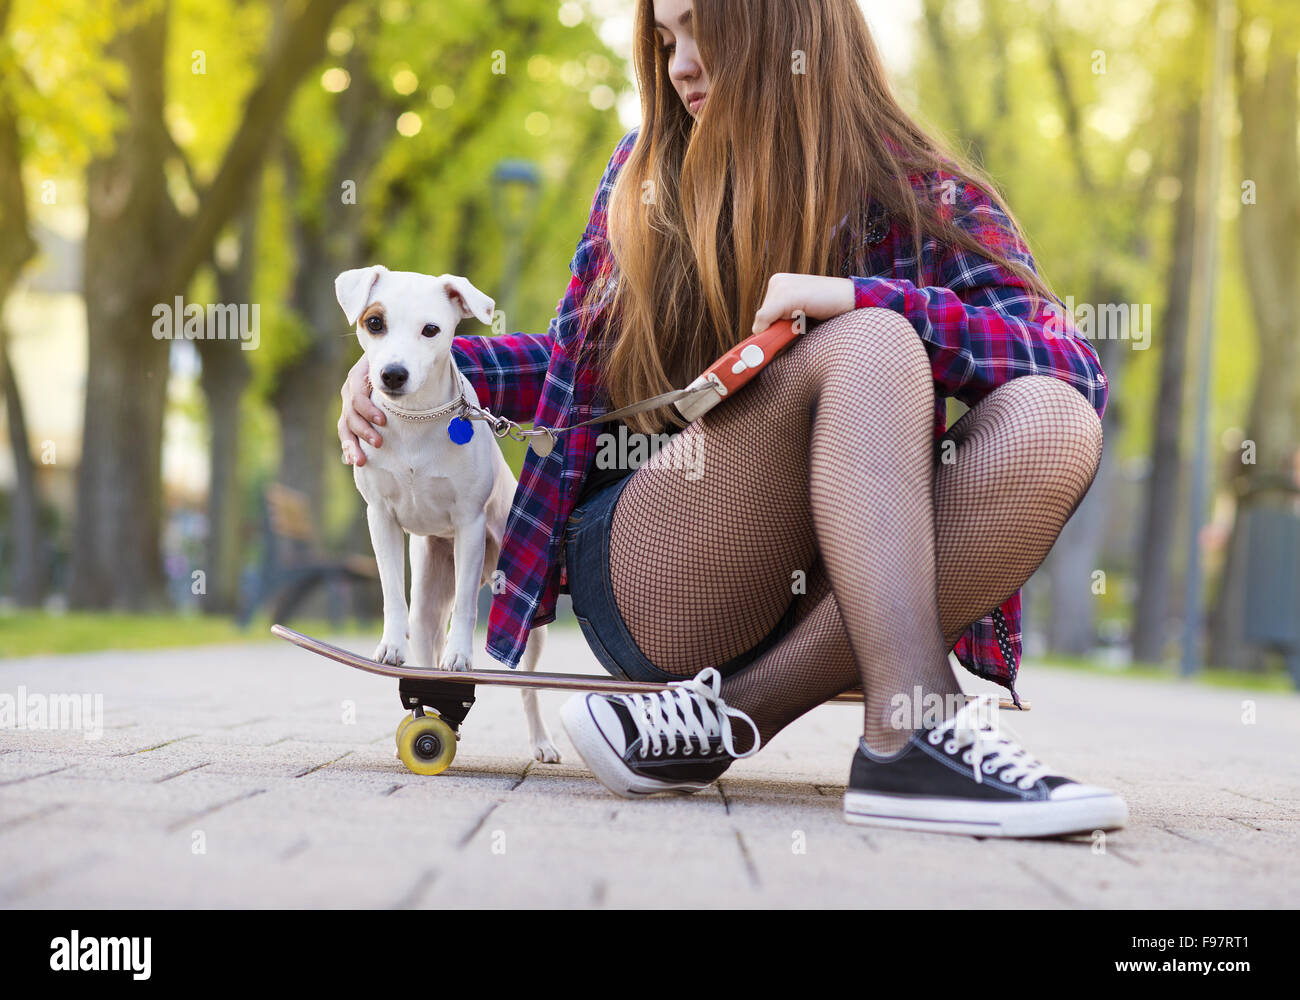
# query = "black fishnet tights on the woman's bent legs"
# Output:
<box><xmin>610</xmin><ymin>309</ymin><xmax>1101</xmax><ymax>753</ymax></box>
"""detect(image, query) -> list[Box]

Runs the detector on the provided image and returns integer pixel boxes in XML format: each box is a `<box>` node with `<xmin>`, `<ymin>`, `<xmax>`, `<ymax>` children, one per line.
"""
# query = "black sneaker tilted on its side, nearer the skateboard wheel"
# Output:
<box><xmin>560</xmin><ymin>667</ymin><xmax>759</xmax><ymax>798</ymax></box>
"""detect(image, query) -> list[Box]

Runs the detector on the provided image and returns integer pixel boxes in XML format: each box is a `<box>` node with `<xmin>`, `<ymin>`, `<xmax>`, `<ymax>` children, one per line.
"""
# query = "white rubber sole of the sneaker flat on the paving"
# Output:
<box><xmin>844</xmin><ymin>791</ymin><xmax>1128</xmax><ymax>837</ymax></box>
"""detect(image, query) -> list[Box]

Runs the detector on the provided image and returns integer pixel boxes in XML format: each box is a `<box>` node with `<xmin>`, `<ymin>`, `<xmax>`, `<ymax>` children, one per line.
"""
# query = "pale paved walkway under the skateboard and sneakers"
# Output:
<box><xmin>0</xmin><ymin>628</ymin><xmax>1300</xmax><ymax>908</ymax></box>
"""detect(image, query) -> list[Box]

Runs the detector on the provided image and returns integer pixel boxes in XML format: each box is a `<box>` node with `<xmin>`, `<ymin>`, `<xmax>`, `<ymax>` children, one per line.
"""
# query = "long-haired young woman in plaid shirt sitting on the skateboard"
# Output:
<box><xmin>339</xmin><ymin>0</ymin><xmax>1127</xmax><ymax>836</ymax></box>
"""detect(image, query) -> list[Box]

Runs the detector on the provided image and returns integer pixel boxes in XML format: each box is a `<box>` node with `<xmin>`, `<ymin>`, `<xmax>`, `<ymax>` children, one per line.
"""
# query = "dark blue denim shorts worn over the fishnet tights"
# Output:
<box><xmin>564</xmin><ymin>475</ymin><xmax>796</xmax><ymax>681</ymax></box>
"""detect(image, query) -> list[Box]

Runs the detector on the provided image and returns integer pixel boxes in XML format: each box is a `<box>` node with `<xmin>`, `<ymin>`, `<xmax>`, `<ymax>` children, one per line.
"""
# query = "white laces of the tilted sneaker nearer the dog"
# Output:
<box><xmin>615</xmin><ymin>667</ymin><xmax>761</xmax><ymax>759</ymax></box>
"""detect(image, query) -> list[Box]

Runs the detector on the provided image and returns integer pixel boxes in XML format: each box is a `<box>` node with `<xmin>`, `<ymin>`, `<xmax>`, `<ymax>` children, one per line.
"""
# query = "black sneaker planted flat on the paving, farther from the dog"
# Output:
<box><xmin>844</xmin><ymin>705</ymin><xmax>1128</xmax><ymax>837</ymax></box>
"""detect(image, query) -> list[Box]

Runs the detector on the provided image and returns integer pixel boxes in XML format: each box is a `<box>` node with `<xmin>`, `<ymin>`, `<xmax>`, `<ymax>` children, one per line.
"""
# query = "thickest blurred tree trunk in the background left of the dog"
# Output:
<box><xmin>69</xmin><ymin>7</ymin><xmax>174</xmax><ymax>609</ymax></box>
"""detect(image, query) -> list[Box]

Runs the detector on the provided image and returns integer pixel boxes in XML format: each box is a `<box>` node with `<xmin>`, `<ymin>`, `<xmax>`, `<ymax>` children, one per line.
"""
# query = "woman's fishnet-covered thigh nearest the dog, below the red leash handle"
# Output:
<box><xmin>610</xmin><ymin>311</ymin><xmax>915</xmax><ymax>674</ymax></box>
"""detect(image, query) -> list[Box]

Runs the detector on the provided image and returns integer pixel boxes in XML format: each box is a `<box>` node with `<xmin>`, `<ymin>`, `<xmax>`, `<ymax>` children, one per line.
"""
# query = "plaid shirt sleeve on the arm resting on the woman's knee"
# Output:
<box><xmin>852</xmin><ymin>175</ymin><xmax>1108</xmax><ymax>415</ymax></box>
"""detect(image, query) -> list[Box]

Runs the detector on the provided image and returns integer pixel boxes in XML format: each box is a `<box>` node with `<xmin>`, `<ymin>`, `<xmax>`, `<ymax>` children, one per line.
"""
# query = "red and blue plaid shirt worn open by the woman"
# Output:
<box><xmin>452</xmin><ymin>129</ymin><xmax>1106</xmax><ymax>696</ymax></box>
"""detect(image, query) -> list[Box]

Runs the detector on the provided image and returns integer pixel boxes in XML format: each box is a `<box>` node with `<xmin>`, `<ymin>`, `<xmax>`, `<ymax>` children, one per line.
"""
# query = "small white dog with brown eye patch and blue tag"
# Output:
<box><xmin>334</xmin><ymin>265</ymin><xmax>560</xmax><ymax>762</ymax></box>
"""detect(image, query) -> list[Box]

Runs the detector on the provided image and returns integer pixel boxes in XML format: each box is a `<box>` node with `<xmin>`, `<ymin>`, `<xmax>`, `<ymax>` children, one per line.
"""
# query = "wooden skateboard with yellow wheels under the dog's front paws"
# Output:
<box><xmin>270</xmin><ymin>624</ymin><xmax>1030</xmax><ymax>775</ymax></box>
